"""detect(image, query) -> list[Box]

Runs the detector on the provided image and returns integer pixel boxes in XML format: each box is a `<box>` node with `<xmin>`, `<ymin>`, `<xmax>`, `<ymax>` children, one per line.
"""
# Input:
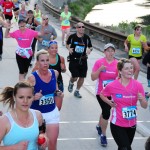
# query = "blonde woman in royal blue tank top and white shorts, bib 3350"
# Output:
<box><xmin>28</xmin><ymin>50</ymin><xmax>63</xmax><ymax>150</ymax></box>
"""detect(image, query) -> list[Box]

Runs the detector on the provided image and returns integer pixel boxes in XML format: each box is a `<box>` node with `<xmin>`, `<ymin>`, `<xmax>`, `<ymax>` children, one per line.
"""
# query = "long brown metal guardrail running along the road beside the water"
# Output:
<box><xmin>43</xmin><ymin>0</ymin><xmax>126</xmax><ymax>50</ymax></box>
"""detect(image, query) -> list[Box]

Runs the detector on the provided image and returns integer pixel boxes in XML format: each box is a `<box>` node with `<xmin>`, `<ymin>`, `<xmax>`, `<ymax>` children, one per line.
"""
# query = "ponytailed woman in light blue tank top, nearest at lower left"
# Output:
<box><xmin>0</xmin><ymin>82</ymin><xmax>47</xmax><ymax>150</ymax></box>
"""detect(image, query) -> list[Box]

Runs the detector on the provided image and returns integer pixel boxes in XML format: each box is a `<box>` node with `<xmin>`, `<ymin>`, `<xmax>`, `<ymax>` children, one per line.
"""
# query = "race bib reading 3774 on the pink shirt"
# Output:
<box><xmin>122</xmin><ymin>106</ymin><xmax>137</xmax><ymax>120</ymax></box>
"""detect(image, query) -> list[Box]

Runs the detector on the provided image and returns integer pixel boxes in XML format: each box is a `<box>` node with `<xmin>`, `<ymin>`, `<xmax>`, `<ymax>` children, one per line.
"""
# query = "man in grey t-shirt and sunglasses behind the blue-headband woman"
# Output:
<box><xmin>36</xmin><ymin>15</ymin><xmax>57</xmax><ymax>51</ymax></box>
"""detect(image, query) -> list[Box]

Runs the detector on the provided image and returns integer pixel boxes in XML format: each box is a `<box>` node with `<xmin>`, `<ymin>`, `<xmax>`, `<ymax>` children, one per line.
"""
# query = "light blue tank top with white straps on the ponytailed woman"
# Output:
<box><xmin>3</xmin><ymin>109</ymin><xmax>39</xmax><ymax>150</ymax></box>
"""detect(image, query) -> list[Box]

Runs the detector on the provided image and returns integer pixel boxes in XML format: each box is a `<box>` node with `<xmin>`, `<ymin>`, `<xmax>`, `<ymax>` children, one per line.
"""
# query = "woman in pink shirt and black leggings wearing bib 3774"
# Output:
<box><xmin>100</xmin><ymin>58</ymin><xmax>147</xmax><ymax>150</ymax></box>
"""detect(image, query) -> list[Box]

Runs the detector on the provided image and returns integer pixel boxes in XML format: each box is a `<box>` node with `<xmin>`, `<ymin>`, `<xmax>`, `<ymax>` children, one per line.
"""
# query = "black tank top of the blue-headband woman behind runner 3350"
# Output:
<box><xmin>49</xmin><ymin>54</ymin><xmax>63</xmax><ymax>84</ymax></box>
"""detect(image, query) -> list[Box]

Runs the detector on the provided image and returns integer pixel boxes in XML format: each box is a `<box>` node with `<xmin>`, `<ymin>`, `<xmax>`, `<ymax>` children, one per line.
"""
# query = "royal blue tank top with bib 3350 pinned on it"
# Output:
<box><xmin>31</xmin><ymin>69</ymin><xmax>56</xmax><ymax>113</ymax></box>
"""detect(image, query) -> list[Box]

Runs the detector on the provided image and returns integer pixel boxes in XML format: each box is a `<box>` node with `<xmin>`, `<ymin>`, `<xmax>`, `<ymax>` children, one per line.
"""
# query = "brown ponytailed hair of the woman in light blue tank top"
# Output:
<box><xmin>0</xmin><ymin>81</ymin><xmax>34</xmax><ymax>108</ymax></box>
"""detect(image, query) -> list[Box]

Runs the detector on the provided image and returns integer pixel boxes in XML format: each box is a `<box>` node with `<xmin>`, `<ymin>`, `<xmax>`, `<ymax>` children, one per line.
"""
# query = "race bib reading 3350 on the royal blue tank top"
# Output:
<box><xmin>39</xmin><ymin>94</ymin><xmax>54</xmax><ymax>105</ymax></box>
